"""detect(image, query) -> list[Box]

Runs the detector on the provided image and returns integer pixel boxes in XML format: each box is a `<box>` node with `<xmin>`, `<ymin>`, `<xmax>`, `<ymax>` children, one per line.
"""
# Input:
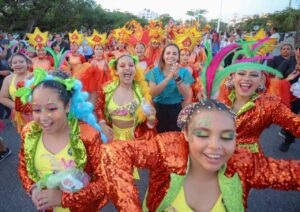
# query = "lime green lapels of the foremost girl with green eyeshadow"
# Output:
<box><xmin>143</xmin><ymin>162</ymin><xmax>244</xmax><ymax>212</ymax></box>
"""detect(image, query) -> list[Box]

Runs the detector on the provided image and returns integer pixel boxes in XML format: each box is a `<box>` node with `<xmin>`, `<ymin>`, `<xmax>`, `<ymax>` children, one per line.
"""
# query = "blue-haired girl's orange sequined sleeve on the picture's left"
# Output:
<box><xmin>18</xmin><ymin>128</ymin><xmax>35</xmax><ymax>193</ymax></box>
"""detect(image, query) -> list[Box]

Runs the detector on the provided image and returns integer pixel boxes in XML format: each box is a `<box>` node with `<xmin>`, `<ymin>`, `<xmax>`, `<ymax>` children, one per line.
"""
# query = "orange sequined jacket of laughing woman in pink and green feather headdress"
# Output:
<box><xmin>219</xmin><ymin>91</ymin><xmax>300</xmax><ymax>153</ymax></box>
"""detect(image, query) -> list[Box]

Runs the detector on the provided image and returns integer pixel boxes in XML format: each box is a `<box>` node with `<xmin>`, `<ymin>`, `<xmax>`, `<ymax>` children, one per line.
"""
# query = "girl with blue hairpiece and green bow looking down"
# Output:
<box><xmin>17</xmin><ymin>69</ymin><xmax>107</xmax><ymax>211</ymax></box>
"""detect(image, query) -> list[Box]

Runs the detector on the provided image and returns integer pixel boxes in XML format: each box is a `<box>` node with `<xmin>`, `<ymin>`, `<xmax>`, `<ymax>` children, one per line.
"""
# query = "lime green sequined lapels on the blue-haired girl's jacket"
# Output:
<box><xmin>24</xmin><ymin>119</ymin><xmax>87</xmax><ymax>182</ymax></box>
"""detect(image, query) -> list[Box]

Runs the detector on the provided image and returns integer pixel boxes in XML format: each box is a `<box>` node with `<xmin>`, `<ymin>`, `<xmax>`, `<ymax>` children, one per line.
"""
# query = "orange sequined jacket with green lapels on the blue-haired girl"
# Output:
<box><xmin>18</xmin><ymin>121</ymin><xmax>107</xmax><ymax>212</ymax></box>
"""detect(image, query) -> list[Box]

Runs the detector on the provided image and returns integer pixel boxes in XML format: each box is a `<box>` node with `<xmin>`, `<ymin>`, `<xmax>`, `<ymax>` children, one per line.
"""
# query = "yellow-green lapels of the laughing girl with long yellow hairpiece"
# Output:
<box><xmin>103</xmin><ymin>80</ymin><xmax>143</xmax><ymax>126</ymax></box>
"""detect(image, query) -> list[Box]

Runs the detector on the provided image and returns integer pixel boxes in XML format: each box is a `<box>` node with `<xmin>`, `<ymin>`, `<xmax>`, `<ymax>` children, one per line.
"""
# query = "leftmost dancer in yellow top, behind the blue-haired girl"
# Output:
<box><xmin>0</xmin><ymin>53</ymin><xmax>32</xmax><ymax>133</ymax></box>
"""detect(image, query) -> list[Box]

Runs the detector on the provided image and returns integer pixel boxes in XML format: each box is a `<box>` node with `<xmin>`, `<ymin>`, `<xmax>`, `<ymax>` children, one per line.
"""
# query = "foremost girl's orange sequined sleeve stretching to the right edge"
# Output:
<box><xmin>226</xmin><ymin>150</ymin><xmax>300</xmax><ymax>207</ymax></box>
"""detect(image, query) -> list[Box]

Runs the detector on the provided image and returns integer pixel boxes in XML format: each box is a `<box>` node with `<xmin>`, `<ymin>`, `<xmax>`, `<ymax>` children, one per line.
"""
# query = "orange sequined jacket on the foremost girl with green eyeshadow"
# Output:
<box><xmin>99</xmin><ymin>132</ymin><xmax>300</xmax><ymax>212</ymax></box>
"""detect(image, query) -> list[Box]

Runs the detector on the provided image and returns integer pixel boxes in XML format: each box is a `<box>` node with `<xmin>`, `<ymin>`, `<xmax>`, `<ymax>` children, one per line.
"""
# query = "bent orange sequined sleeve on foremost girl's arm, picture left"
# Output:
<box><xmin>98</xmin><ymin>139</ymin><xmax>160</xmax><ymax>212</ymax></box>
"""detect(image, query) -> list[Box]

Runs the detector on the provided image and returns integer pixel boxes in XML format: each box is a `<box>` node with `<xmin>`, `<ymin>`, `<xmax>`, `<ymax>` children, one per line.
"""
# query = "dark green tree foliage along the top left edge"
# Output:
<box><xmin>0</xmin><ymin>0</ymin><xmax>147</xmax><ymax>32</ymax></box>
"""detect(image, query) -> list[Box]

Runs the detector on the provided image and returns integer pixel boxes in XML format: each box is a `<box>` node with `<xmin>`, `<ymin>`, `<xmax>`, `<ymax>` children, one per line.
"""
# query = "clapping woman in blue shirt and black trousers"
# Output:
<box><xmin>146</xmin><ymin>44</ymin><xmax>194</xmax><ymax>132</ymax></box>
